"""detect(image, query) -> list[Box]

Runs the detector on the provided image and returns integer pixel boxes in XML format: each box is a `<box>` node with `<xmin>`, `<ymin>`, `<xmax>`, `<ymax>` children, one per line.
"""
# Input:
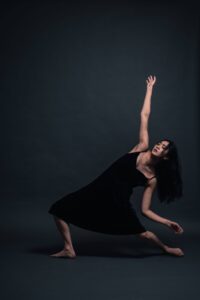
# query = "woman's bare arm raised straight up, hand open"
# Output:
<box><xmin>132</xmin><ymin>75</ymin><xmax>156</xmax><ymax>152</ymax></box>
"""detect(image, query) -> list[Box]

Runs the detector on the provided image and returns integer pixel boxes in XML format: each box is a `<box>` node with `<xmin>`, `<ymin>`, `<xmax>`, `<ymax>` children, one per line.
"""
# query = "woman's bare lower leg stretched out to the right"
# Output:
<box><xmin>139</xmin><ymin>231</ymin><xmax>184</xmax><ymax>256</ymax></box>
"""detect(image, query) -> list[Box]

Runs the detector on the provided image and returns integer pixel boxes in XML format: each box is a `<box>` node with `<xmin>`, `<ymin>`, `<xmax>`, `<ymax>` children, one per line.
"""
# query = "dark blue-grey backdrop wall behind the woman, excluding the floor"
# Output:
<box><xmin>1</xmin><ymin>1</ymin><xmax>200</xmax><ymax>218</ymax></box>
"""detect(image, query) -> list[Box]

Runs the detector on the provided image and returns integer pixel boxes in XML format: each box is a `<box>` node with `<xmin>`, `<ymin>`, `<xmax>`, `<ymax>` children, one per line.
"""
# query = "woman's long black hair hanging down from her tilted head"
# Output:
<box><xmin>155</xmin><ymin>139</ymin><xmax>183</xmax><ymax>203</ymax></box>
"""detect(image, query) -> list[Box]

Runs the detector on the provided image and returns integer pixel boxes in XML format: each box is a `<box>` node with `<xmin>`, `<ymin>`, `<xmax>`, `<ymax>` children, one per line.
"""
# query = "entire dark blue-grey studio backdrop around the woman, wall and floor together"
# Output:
<box><xmin>0</xmin><ymin>0</ymin><xmax>200</xmax><ymax>300</ymax></box>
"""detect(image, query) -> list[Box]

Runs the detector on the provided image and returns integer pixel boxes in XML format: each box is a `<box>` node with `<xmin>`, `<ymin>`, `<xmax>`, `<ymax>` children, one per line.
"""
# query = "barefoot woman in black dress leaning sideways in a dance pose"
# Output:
<box><xmin>48</xmin><ymin>76</ymin><xmax>184</xmax><ymax>258</ymax></box>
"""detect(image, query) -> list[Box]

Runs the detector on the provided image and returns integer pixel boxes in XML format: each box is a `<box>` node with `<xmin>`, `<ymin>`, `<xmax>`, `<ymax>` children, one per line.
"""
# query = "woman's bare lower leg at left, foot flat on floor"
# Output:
<box><xmin>50</xmin><ymin>216</ymin><xmax>76</xmax><ymax>258</ymax></box>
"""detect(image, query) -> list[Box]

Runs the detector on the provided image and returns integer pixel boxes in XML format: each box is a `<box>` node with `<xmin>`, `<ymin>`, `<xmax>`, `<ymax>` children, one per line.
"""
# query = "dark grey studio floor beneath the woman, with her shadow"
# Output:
<box><xmin>1</xmin><ymin>202</ymin><xmax>200</xmax><ymax>300</ymax></box>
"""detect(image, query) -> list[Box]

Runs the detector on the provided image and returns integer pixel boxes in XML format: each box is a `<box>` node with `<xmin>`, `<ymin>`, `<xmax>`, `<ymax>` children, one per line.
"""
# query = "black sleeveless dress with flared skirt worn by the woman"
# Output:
<box><xmin>48</xmin><ymin>151</ymin><xmax>154</xmax><ymax>235</ymax></box>
